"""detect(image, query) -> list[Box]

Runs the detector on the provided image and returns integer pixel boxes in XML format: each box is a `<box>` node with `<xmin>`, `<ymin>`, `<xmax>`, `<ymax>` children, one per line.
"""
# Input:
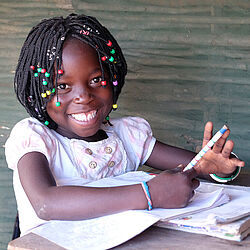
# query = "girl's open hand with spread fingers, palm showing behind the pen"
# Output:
<box><xmin>194</xmin><ymin>122</ymin><xmax>245</xmax><ymax>175</ymax></box>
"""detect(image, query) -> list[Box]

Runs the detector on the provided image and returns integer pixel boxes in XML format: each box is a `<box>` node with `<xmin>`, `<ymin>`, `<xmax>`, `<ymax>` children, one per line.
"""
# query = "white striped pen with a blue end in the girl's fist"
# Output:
<box><xmin>183</xmin><ymin>125</ymin><xmax>228</xmax><ymax>171</ymax></box>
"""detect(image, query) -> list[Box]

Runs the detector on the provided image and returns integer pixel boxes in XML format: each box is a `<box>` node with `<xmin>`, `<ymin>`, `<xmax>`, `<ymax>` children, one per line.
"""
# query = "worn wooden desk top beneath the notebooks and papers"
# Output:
<box><xmin>8</xmin><ymin>173</ymin><xmax>250</xmax><ymax>250</ymax></box>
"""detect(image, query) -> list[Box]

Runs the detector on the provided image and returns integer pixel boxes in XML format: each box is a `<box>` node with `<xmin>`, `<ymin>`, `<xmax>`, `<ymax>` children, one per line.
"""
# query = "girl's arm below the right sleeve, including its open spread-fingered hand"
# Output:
<box><xmin>146</xmin><ymin>122</ymin><xmax>244</xmax><ymax>179</ymax></box>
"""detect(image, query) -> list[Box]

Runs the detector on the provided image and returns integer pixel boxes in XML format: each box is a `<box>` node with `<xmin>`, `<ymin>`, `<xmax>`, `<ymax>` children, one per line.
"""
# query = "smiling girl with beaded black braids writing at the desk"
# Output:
<box><xmin>6</xmin><ymin>14</ymin><xmax>244</xmax><ymax>234</ymax></box>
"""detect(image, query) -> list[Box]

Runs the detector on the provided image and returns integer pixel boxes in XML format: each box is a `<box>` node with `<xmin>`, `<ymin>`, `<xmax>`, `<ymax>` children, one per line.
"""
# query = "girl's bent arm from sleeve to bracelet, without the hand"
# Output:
<box><xmin>18</xmin><ymin>152</ymin><xmax>147</xmax><ymax>220</ymax></box>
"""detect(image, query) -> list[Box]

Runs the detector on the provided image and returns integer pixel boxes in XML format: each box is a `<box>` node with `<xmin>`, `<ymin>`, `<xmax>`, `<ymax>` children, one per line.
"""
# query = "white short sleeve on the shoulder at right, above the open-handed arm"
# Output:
<box><xmin>111</xmin><ymin>117</ymin><xmax>156</xmax><ymax>166</ymax></box>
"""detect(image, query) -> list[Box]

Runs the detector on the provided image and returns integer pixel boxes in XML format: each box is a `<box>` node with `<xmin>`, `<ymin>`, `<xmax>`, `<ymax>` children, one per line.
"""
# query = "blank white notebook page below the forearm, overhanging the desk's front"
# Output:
<box><xmin>32</xmin><ymin>211</ymin><xmax>159</xmax><ymax>250</ymax></box>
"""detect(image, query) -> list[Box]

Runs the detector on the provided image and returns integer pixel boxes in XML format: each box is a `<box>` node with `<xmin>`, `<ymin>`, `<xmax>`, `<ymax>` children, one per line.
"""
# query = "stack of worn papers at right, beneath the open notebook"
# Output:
<box><xmin>157</xmin><ymin>183</ymin><xmax>250</xmax><ymax>241</ymax></box>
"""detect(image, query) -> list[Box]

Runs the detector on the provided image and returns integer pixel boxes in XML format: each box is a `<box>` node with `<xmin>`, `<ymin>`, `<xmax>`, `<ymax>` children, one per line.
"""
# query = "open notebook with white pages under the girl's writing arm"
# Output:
<box><xmin>32</xmin><ymin>171</ymin><xmax>232</xmax><ymax>250</ymax></box>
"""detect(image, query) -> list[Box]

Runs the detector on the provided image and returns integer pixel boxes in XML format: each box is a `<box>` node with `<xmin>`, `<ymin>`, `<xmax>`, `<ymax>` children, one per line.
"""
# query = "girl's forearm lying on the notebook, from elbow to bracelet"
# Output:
<box><xmin>32</xmin><ymin>184</ymin><xmax>147</xmax><ymax>220</ymax></box>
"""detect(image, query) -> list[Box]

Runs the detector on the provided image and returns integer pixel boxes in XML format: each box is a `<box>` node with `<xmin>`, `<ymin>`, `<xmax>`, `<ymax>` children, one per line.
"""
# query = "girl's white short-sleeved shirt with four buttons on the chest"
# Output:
<box><xmin>5</xmin><ymin>117</ymin><xmax>156</xmax><ymax>235</ymax></box>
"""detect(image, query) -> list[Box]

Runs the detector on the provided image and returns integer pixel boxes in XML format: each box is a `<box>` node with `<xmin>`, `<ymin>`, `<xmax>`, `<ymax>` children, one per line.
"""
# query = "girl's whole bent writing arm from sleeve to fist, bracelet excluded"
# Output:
<box><xmin>18</xmin><ymin>152</ymin><xmax>199</xmax><ymax>220</ymax></box>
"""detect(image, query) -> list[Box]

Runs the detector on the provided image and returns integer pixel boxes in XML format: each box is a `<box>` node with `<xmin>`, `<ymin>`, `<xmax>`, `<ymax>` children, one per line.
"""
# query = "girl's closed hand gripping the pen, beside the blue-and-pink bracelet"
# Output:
<box><xmin>147</xmin><ymin>168</ymin><xmax>199</xmax><ymax>208</ymax></box>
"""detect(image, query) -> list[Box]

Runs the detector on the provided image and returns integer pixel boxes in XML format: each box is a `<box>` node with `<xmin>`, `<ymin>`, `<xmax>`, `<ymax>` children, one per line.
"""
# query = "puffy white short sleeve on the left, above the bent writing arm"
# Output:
<box><xmin>5</xmin><ymin>118</ymin><xmax>55</xmax><ymax>170</ymax></box>
